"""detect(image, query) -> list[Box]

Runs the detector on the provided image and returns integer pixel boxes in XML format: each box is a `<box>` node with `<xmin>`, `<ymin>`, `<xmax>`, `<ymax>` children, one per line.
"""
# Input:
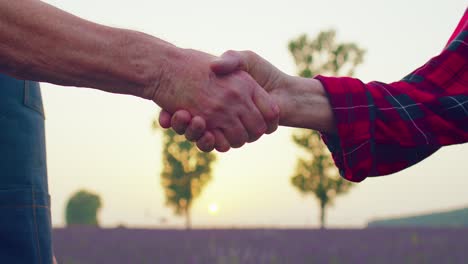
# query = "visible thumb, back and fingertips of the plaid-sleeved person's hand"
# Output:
<box><xmin>159</xmin><ymin>51</ymin><xmax>288</xmax><ymax>152</ymax></box>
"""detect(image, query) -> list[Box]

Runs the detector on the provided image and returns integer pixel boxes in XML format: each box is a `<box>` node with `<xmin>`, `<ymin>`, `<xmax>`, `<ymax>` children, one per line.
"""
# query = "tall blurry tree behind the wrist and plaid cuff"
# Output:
<box><xmin>289</xmin><ymin>30</ymin><xmax>364</xmax><ymax>228</ymax></box>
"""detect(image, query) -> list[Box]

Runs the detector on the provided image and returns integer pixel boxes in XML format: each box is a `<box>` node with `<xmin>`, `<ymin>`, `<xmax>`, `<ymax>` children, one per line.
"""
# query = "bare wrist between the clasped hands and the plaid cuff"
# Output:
<box><xmin>272</xmin><ymin>76</ymin><xmax>336</xmax><ymax>133</ymax></box>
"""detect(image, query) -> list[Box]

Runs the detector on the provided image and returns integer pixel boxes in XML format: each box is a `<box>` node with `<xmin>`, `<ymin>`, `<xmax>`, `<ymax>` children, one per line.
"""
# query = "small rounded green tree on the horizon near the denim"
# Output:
<box><xmin>65</xmin><ymin>190</ymin><xmax>102</xmax><ymax>226</ymax></box>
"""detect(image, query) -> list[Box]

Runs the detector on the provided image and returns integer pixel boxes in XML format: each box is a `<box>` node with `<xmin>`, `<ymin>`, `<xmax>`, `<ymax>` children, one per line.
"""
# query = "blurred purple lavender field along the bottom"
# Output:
<box><xmin>54</xmin><ymin>227</ymin><xmax>468</xmax><ymax>264</ymax></box>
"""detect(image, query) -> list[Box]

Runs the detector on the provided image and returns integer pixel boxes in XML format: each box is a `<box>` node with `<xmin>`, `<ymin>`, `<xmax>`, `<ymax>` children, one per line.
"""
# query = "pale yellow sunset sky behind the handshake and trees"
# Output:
<box><xmin>42</xmin><ymin>0</ymin><xmax>468</xmax><ymax>227</ymax></box>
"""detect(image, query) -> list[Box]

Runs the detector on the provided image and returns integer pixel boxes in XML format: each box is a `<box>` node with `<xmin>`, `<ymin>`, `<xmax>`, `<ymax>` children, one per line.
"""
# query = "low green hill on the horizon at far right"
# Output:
<box><xmin>367</xmin><ymin>208</ymin><xmax>468</xmax><ymax>227</ymax></box>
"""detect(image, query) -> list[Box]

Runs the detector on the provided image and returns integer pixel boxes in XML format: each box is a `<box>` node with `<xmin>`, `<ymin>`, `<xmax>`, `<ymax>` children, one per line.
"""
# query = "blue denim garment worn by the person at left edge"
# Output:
<box><xmin>0</xmin><ymin>74</ymin><xmax>52</xmax><ymax>264</ymax></box>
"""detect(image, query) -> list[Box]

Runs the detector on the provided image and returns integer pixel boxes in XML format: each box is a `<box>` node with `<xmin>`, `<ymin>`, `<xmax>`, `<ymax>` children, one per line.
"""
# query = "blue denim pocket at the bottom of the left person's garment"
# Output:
<box><xmin>0</xmin><ymin>188</ymin><xmax>52</xmax><ymax>264</ymax></box>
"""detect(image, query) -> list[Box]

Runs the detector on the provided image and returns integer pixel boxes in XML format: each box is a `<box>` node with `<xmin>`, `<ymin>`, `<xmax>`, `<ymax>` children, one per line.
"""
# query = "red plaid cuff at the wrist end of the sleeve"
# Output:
<box><xmin>315</xmin><ymin>75</ymin><xmax>376</xmax><ymax>182</ymax></box>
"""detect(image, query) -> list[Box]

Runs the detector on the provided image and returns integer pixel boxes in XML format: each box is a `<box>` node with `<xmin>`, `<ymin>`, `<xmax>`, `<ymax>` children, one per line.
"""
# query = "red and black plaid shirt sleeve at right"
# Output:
<box><xmin>316</xmin><ymin>12</ymin><xmax>468</xmax><ymax>182</ymax></box>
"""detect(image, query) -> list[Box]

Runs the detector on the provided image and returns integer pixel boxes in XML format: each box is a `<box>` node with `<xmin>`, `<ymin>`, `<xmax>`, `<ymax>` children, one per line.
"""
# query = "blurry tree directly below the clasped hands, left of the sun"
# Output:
<box><xmin>153</xmin><ymin>121</ymin><xmax>216</xmax><ymax>229</ymax></box>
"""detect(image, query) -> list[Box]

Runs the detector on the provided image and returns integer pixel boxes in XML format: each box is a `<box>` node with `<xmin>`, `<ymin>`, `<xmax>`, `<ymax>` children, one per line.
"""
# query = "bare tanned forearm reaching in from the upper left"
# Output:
<box><xmin>0</xmin><ymin>0</ymin><xmax>177</xmax><ymax>99</ymax></box>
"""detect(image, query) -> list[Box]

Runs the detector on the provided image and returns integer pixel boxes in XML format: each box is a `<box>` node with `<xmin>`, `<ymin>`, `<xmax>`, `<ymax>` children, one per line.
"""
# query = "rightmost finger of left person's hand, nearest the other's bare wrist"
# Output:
<box><xmin>253</xmin><ymin>87</ymin><xmax>280</xmax><ymax>134</ymax></box>
